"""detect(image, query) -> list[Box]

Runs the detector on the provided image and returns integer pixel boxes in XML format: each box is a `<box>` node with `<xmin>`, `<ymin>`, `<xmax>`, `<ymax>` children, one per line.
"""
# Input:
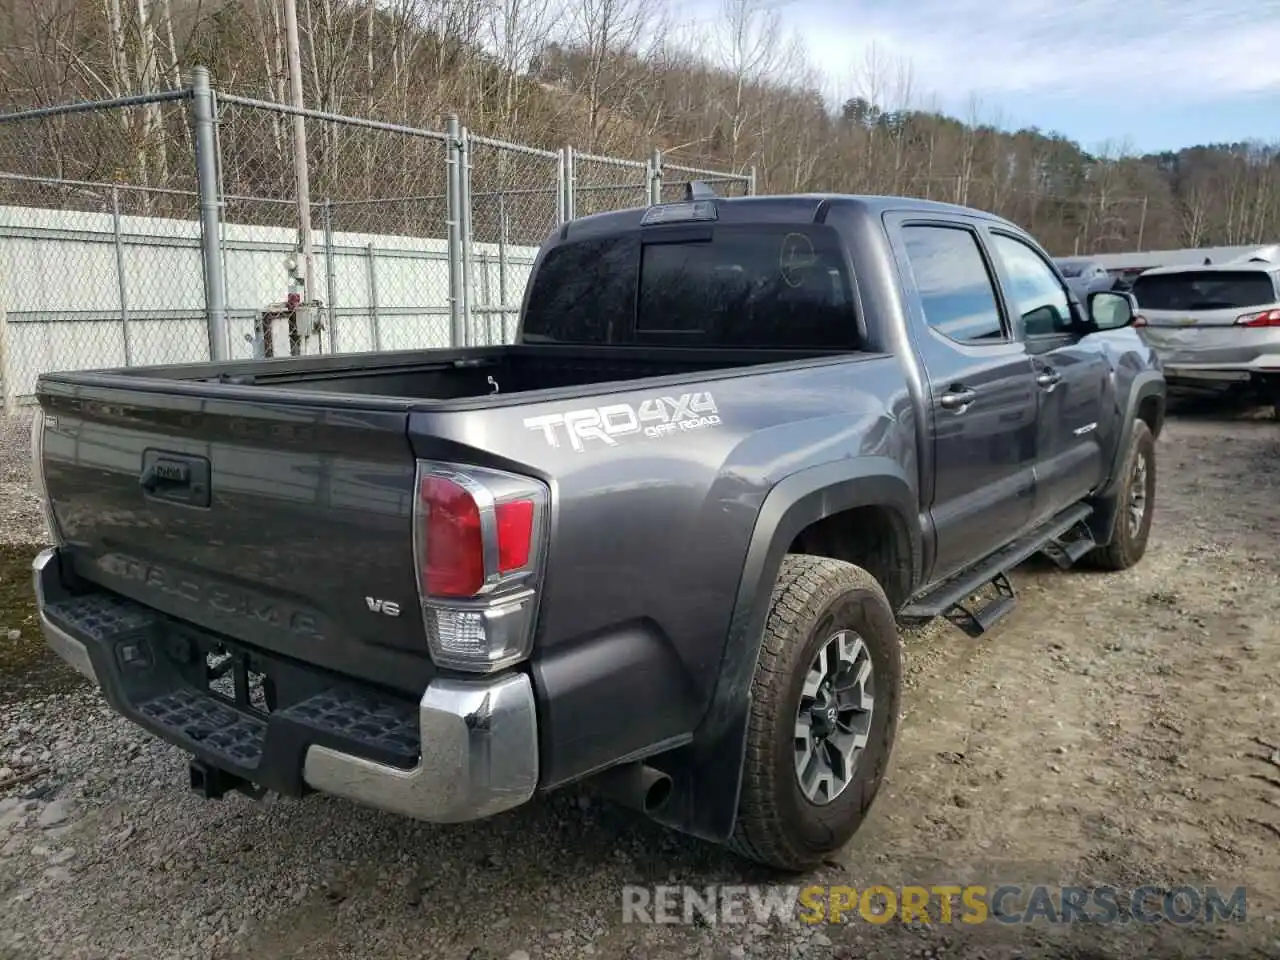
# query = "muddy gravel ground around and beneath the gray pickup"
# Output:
<box><xmin>0</xmin><ymin>401</ymin><xmax>1280</xmax><ymax>960</ymax></box>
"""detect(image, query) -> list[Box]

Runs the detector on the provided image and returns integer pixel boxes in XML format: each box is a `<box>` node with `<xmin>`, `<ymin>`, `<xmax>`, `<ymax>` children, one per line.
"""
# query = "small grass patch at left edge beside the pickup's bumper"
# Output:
<box><xmin>0</xmin><ymin>544</ymin><xmax>86</xmax><ymax>703</ymax></box>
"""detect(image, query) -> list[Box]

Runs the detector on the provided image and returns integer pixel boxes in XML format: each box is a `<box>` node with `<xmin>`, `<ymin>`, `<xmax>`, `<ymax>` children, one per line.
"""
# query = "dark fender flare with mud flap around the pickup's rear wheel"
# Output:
<box><xmin>654</xmin><ymin>457</ymin><xmax>923</xmax><ymax>842</ymax></box>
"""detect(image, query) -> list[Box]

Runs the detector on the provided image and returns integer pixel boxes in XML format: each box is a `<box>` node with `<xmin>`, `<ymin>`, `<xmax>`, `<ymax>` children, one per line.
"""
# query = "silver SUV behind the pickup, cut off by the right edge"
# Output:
<box><xmin>1133</xmin><ymin>261</ymin><xmax>1280</xmax><ymax>401</ymax></box>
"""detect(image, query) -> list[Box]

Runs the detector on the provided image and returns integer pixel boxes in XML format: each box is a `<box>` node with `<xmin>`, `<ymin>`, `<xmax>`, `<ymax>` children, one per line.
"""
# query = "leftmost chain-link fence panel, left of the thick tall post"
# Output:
<box><xmin>0</xmin><ymin>92</ymin><xmax>210</xmax><ymax>404</ymax></box>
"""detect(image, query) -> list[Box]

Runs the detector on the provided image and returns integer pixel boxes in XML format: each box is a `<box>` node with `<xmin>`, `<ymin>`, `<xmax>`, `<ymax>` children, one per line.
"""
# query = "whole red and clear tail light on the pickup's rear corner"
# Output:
<box><xmin>413</xmin><ymin>461</ymin><xmax>550</xmax><ymax>673</ymax></box>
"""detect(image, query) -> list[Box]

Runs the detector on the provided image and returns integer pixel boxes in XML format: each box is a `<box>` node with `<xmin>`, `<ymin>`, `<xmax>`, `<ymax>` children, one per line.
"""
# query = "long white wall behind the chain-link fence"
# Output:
<box><xmin>0</xmin><ymin>206</ymin><xmax>538</xmax><ymax>398</ymax></box>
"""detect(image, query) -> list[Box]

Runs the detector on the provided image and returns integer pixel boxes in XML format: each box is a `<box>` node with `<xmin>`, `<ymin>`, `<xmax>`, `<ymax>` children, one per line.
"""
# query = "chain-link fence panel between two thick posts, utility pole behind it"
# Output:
<box><xmin>218</xmin><ymin>96</ymin><xmax>453</xmax><ymax>357</ymax></box>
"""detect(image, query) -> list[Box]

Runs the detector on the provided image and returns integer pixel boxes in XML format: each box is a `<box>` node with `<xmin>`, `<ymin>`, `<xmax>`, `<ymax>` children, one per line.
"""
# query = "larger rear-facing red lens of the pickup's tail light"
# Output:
<box><xmin>420</xmin><ymin>475</ymin><xmax>484</xmax><ymax>596</ymax></box>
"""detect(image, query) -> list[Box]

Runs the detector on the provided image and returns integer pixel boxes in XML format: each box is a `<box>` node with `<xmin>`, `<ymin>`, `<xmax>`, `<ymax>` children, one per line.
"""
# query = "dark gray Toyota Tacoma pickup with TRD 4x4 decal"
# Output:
<box><xmin>33</xmin><ymin>187</ymin><xmax>1165</xmax><ymax>870</ymax></box>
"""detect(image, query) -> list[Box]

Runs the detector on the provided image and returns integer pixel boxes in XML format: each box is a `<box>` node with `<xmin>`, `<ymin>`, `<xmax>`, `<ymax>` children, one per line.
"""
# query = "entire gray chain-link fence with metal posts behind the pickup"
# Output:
<box><xmin>0</xmin><ymin>68</ymin><xmax>754</xmax><ymax>408</ymax></box>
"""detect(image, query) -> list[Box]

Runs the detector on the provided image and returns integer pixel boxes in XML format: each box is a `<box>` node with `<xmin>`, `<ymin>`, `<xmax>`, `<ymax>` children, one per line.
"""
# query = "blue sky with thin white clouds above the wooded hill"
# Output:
<box><xmin>680</xmin><ymin>0</ymin><xmax>1280</xmax><ymax>152</ymax></box>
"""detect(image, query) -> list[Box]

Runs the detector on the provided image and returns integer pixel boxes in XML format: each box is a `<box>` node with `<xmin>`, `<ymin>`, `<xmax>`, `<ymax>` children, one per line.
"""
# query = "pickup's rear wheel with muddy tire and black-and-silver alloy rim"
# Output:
<box><xmin>728</xmin><ymin>554</ymin><xmax>902</xmax><ymax>872</ymax></box>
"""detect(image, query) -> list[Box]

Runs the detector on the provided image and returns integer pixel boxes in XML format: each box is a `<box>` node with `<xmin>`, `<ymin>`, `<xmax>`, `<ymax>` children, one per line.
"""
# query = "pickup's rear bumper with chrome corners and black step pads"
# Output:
<box><xmin>32</xmin><ymin>549</ymin><xmax>539</xmax><ymax>823</ymax></box>
